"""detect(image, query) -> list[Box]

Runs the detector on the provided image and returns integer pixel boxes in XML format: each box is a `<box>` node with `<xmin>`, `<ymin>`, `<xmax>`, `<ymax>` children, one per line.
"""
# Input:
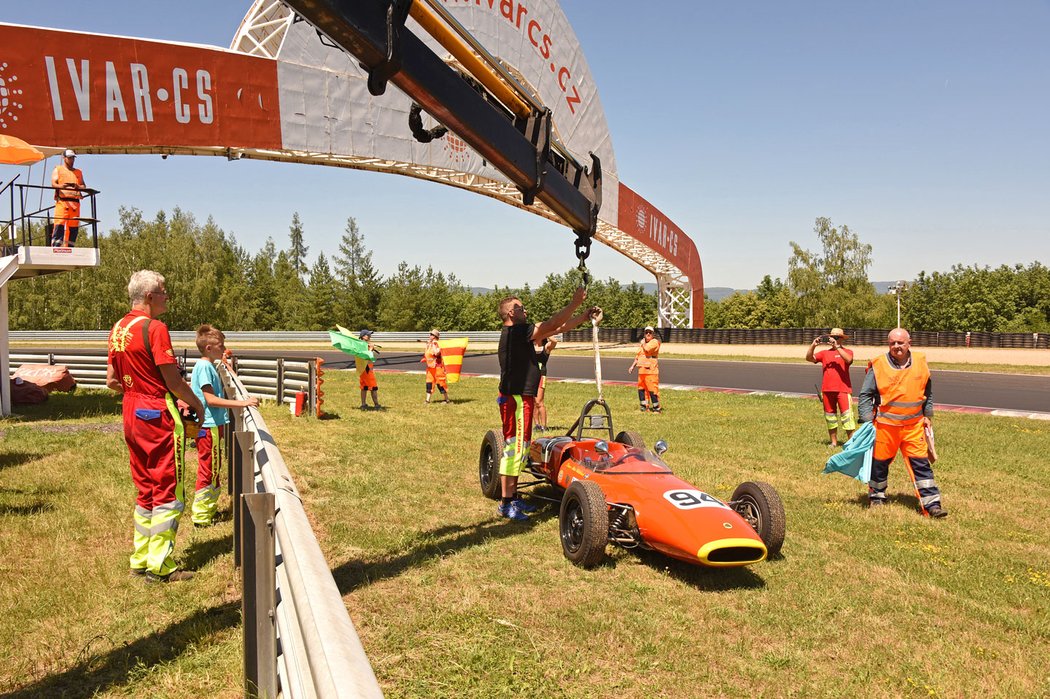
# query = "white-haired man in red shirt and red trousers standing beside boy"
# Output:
<box><xmin>106</xmin><ymin>270</ymin><xmax>204</xmax><ymax>583</ymax></box>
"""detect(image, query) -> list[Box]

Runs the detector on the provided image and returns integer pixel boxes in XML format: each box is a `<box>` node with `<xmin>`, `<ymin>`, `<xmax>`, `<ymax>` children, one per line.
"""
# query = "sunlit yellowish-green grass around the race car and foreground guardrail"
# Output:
<box><xmin>0</xmin><ymin>372</ymin><xmax>1050</xmax><ymax>698</ymax></box>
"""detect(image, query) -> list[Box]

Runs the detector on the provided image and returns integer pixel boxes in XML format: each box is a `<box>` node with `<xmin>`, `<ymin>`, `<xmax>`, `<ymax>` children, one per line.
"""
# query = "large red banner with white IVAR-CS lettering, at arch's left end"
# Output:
<box><xmin>0</xmin><ymin>24</ymin><xmax>281</xmax><ymax>148</ymax></box>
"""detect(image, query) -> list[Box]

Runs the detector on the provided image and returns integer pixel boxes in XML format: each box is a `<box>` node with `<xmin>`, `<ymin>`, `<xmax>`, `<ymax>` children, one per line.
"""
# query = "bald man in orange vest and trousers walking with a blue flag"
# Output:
<box><xmin>859</xmin><ymin>327</ymin><xmax>948</xmax><ymax>518</ymax></box>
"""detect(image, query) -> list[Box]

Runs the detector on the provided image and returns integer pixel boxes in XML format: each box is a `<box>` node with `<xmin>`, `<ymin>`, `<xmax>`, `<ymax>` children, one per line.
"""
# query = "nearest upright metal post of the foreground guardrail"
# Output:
<box><xmin>239</xmin><ymin>492</ymin><xmax>277</xmax><ymax>698</ymax></box>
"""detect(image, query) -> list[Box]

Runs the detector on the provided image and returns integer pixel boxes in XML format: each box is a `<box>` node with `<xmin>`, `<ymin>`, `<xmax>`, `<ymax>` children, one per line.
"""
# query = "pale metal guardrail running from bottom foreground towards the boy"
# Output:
<box><xmin>223</xmin><ymin>367</ymin><xmax>382</xmax><ymax>698</ymax></box>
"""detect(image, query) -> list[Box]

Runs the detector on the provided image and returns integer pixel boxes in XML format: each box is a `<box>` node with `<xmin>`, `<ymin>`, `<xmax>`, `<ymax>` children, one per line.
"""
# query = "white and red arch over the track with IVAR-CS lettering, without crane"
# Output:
<box><xmin>0</xmin><ymin>0</ymin><xmax>704</xmax><ymax>327</ymax></box>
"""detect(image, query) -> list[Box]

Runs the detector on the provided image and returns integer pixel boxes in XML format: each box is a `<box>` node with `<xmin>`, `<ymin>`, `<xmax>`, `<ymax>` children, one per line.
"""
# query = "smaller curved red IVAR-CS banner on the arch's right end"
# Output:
<box><xmin>616</xmin><ymin>183</ymin><xmax>704</xmax><ymax>327</ymax></box>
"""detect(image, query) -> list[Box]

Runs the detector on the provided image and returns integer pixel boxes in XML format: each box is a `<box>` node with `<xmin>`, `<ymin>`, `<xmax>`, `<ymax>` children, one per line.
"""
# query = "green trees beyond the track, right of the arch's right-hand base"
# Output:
<box><xmin>705</xmin><ymin>217</ymin><xmax>1050</xmax><ymax>333</ymax></box>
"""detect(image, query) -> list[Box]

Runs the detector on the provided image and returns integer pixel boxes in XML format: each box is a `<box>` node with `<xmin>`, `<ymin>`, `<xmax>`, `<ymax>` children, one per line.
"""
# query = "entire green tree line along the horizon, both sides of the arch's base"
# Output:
<box><xmin>11</xmin><ymin>209</ymin><xmax>1050</xmax><ymax>332</ymax></box>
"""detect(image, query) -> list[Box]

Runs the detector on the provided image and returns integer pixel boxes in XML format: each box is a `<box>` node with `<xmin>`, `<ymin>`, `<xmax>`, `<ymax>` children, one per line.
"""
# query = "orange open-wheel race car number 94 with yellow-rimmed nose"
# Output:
<box><xmin>478</xmin><ymin>399</ymin><xmax>784</xmax><ymax>568</ymax></box>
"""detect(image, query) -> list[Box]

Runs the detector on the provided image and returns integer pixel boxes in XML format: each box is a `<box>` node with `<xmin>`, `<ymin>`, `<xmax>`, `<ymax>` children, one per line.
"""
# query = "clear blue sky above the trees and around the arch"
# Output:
<box><xmin>0</xmin><ymin>0</ymin><xmax>1050</xmax><ymax>289</ymax></box>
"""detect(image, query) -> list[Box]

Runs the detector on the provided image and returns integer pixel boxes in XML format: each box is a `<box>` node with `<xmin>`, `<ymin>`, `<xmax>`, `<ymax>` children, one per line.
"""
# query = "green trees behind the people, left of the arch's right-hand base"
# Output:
<box><xmin>9</xmin><ymin>209</ymin><xmax>656</xmax><ymax>331</ymax></box>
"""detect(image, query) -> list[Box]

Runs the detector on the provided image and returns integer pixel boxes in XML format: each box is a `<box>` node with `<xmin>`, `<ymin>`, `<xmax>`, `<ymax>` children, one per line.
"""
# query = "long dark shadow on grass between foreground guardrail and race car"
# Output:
<box><xmin>332</xmin><ymin>503</ymin><xmax>558</xmax><ymax>595</ymax></box>
